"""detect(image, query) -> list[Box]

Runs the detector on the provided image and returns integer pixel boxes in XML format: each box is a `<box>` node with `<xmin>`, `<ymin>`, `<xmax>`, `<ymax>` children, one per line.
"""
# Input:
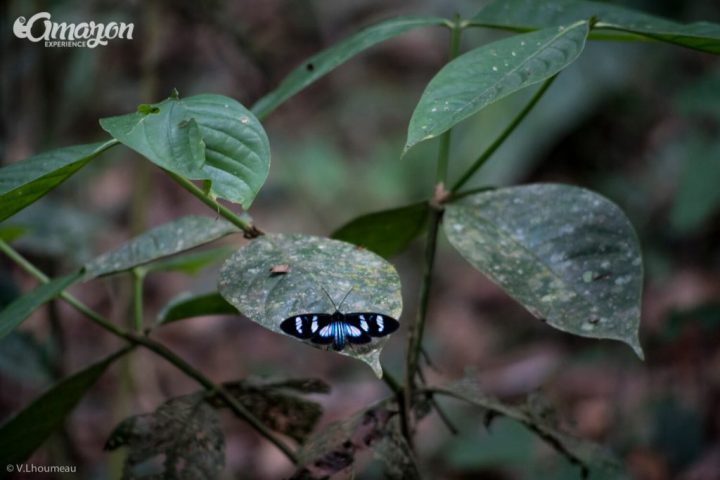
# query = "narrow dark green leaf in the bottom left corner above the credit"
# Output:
<box><xmin>0</xmin><ymin>348</ymin><xmax>129</xmax><ymax>465</ymax></box>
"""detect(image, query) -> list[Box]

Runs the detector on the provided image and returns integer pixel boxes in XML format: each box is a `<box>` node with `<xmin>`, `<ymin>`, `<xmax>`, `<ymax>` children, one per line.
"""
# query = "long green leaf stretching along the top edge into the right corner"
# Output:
<box><xmin>470</xmin><ymin>0</ymin><xmax>720</xmax><ymax>54</ymax></box>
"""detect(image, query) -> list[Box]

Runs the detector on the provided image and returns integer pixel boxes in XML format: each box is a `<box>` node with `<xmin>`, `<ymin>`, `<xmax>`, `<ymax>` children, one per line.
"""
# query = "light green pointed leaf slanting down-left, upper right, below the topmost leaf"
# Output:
<box><xmin>405</xmin><ymin>22</ymin><xmax>588</xmax><ymax>151</ymax></box>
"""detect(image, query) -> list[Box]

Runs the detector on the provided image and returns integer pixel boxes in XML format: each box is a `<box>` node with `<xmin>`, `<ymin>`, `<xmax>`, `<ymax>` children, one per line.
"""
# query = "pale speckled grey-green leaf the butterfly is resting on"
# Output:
<box><xmin>218</xmin><ymin>235</ymin><xmax>402</xmax><ymax>377</ymax></box>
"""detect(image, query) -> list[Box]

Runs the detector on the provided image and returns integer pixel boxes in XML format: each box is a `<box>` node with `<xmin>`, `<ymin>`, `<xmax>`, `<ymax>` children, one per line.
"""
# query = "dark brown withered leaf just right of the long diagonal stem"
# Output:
<box><xmin>211</xmin><ymin>378</ymin><xmax>330</xmax><ymax>443</ymax></box>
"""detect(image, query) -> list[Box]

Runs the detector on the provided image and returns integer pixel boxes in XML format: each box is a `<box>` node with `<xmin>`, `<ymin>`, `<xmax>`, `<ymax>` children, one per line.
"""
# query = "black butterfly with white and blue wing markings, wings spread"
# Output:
<box><xmin>280</xmin><ymin>289</ymin><xmax>400</xmax><ymax>352</ymax></box>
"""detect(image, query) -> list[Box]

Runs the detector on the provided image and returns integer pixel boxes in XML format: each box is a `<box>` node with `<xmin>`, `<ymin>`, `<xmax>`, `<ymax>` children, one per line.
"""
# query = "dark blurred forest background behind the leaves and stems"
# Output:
<box><xmin>0</xmin><ymin>0</ymin><xmax>720</xmax><ymax>480</ymax></box>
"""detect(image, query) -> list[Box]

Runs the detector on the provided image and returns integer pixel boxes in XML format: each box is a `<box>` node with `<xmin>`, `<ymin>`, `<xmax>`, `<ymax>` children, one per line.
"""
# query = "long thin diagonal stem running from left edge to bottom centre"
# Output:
<box><xmin>0</xmin><ymin>240</ymin><xmax>298</xmax><ymax>464</ymax></box>
